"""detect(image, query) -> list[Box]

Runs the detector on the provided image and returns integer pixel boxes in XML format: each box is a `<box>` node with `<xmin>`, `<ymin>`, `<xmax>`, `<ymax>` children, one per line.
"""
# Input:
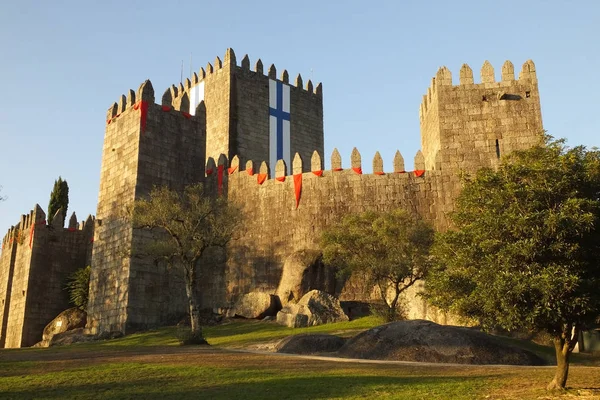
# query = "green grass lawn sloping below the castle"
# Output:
<box><xmin>0</xmin><ymin>318</ymin><xmax>600</xmax><ymax>399</ymax></box>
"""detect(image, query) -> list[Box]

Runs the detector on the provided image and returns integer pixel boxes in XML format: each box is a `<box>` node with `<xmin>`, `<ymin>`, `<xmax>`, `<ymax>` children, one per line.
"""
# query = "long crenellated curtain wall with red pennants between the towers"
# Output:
<box><xmin>201</xmin><ymin>150</ymin><xmax>460</xmax><ymax>318</ymax></box>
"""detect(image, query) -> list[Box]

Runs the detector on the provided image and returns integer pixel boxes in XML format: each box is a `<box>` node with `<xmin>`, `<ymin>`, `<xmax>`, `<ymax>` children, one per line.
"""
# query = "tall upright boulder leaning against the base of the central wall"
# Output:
<box><xmin>275</xmin><ymin>250</ymin><xmax>337</xmax><ymax>306</ymax></box>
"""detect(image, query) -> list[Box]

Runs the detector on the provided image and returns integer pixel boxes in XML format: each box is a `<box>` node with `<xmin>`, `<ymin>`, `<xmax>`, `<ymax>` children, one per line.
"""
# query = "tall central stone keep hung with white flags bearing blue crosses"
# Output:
<box><xmin>162</xmin><ymin>49</ymin><xmax>324</xmax><ymax>174</ymax></box>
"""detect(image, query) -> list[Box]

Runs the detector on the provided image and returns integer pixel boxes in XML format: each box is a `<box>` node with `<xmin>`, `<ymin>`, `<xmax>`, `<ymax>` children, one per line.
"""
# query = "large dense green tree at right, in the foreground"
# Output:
<box><xmin>426</xmin><ymin>137</ymin><xmax>600</xmax><ymax>390</ymax></box>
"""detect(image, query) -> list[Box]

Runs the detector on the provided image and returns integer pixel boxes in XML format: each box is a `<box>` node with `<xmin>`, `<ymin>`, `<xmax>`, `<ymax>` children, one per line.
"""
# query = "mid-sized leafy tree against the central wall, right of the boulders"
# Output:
<box><xmin>321</xmin><ymin>210</ymin><xmax>434</xmax><ymax>321</ymax></box>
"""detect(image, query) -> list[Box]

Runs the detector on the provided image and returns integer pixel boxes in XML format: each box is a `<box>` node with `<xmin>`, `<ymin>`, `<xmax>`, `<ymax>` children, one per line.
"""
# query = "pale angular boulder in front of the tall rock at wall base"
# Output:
<box><xmin>277</xmin><ymin>290</ymin><xmax>348</xmax><ymax>328</ymax></box>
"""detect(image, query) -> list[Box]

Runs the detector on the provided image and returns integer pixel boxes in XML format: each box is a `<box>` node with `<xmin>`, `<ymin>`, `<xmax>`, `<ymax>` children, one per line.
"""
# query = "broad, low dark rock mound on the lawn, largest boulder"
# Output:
<box><xmin>338</xmin><ymin>320</ymin><xmax>545</xmax><ymax>365</ymax></box>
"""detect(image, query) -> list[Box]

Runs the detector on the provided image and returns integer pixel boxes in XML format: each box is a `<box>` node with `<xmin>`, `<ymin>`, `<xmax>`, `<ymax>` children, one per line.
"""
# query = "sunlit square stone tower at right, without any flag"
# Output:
<box><xmin>419</xmin><ymin>60</ymin><xmax>543</xmax><ymax>172</ymax></box>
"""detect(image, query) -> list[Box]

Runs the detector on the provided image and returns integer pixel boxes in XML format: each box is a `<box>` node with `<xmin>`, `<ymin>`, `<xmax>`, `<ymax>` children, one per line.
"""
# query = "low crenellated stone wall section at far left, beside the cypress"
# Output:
<box><xmin>0</xmin><ymin>206</ymin><xmax>94</xmax><ymax>347</ymax></box>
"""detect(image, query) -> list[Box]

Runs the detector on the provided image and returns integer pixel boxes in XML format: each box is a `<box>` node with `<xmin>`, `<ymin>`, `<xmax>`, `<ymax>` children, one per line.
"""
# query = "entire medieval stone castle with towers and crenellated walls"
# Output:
<box><xmin>0</xmin><ymin>49</ymin><xmax>543</xmax><ymax>347</ymax></box>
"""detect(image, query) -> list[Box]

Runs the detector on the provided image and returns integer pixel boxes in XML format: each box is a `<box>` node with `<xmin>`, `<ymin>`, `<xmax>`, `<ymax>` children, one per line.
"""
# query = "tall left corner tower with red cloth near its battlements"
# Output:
<box><xmin>88</xmin><ymin>81</ymin><xmax>206</xmax><ymax>332</ymax></box>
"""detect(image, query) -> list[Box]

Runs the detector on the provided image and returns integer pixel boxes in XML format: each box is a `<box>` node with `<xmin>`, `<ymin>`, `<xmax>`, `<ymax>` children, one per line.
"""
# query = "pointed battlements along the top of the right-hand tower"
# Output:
<box><xmin>419</xmin><ymin>60</ymin><xmax>537</xmax><ymax>121</ymax></box>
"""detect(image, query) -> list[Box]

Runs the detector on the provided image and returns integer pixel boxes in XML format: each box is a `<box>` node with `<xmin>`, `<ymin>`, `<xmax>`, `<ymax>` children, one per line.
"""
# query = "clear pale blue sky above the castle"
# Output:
<box><xmin>0</xmin><ymin>0</ymin><xmax>600</xmax><ymax>236</ymax></box>
